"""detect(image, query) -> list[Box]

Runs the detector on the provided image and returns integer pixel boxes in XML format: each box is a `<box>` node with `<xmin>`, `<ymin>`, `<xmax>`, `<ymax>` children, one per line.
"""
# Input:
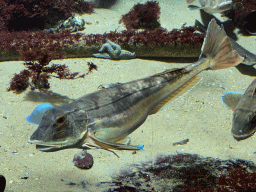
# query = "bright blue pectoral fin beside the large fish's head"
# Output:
<box><xmin>26</xmin><ymin>103</ymin><xmax>53</xmax><ymax>125</ymax></box>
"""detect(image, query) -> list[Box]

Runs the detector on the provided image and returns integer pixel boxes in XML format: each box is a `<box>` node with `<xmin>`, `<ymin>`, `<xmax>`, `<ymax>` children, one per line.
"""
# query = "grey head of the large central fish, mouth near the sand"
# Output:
<box><xmin>28</xmin><ymin>107</ymin><xmax>88</xmax><ymax>152</ymax></box>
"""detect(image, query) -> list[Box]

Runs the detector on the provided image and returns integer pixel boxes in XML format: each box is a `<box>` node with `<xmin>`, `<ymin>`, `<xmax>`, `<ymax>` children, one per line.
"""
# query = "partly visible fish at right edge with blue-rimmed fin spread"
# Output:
<box><xmin>222</xmin><ymin>79</ymin><xmax>256</xmax><ymax>141</ymax></box>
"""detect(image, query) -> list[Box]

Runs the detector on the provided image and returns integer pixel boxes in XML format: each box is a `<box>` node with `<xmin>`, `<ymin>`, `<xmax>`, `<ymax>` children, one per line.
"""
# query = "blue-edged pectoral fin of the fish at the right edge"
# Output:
<box><xmin>222</xmin><ymin>92</ymin><xmax>244</xmax><ymax>111</ymax></box>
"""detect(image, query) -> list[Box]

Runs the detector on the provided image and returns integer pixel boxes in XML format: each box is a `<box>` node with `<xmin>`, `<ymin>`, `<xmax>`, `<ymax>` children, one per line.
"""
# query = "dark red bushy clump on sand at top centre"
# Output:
<box><xmin>120</xmin><ymin>1</ymin><xmax>160</xmax><ymax>30</ymax></box>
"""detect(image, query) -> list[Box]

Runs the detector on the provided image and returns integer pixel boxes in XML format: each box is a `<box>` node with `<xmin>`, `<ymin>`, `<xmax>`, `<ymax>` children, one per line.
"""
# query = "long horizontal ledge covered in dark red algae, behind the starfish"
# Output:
<box><xmin>0</xmin><ymin>25</ymin><xmax>205</xmax><ymax>61</ymax></box>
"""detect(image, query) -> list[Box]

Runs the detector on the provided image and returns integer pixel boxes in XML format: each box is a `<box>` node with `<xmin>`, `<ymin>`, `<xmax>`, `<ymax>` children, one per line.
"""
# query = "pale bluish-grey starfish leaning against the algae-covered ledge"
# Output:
<box><xmin>92</xmin><ymin>40</ymin><xmax>136</xmax><ymax>60</ymax></box>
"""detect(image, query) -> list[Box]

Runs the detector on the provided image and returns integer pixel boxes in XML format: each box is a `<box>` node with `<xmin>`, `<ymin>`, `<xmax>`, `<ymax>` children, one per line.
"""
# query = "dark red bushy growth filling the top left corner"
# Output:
<box><xmin>0</xmin><ymin>0</ymin><xmax>93</xmax><ymax>31</ymax></box>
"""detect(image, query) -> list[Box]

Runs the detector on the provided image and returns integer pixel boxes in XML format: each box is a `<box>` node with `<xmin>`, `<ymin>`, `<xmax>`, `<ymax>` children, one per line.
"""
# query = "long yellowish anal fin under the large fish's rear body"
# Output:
<box><xmin>149</xmin><ymin>76</ymin><xmax>202</xmax><ymax>115</ymax></box>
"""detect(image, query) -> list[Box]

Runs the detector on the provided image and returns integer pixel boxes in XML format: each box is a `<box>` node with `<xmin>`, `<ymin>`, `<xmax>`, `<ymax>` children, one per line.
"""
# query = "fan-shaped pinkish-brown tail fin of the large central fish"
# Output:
<box><xmin>199</xmin><ymin>19</ymin><xmax>244</xmax><ymax>70</ymax></box>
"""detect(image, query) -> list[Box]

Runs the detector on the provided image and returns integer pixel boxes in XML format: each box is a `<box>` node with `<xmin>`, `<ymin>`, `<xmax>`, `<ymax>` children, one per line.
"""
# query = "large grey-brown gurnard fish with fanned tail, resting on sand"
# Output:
<box><xmin>28</xmin><ymin>20</ymin><xmax>243</xmax><ymax>153</ymax></box>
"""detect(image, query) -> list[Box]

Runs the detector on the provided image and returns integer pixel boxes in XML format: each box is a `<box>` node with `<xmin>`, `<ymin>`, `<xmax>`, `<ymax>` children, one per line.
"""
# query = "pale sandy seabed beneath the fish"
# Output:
<box><xmin>0</xmin><ymin>0</ymin><xmax>256</xmax><ymax>192</ymax></box>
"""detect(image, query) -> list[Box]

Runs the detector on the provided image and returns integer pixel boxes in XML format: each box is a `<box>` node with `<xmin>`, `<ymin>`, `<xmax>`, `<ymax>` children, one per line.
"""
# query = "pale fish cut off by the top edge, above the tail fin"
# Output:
<box><xmin>187</xmin><ymin>0</ymin><xmax>232</xmax><ymax>14</ymax></box>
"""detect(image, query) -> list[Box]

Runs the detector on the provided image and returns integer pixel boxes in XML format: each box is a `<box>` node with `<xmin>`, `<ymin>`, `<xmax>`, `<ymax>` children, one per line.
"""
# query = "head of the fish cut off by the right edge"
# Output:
<box><xmin>231</xmin><ymin>109</ymin><xmax>256</xmax><ymax>141</ymax></box>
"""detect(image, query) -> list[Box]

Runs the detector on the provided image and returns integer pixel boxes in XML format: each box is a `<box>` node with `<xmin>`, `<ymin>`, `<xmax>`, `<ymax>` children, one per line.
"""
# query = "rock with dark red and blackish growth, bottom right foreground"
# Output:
<box><xmin>101</xmin><ymin>153</ymin><xmax>256</xmax><ymax>192</ymax></box>
